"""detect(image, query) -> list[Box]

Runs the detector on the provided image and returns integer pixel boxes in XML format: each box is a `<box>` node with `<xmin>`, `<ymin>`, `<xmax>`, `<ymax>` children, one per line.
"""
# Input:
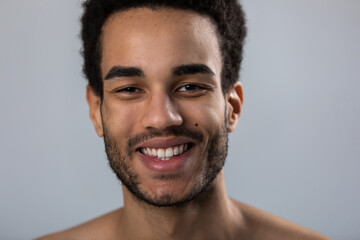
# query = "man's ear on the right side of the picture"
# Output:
<box><xmin>226</xmin><ymin>82</ymin><xmax>244</xmax><ymax>132</ymax></box>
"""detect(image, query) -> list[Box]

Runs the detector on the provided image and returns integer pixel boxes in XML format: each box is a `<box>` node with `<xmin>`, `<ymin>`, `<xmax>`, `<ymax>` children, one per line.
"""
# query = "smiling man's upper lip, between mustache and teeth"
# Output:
<box><xmin>136</xmin><ymin>137</ymin><xmax>193</xmax><ymax>149</ymax></box>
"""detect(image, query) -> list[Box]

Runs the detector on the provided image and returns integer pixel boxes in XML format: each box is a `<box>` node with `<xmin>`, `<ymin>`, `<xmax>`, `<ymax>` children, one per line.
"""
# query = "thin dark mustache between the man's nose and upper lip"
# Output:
<box><xmin>126</xmin><ymin>127</ymin><xmax>204</xmax><ymax>155</ymax></box>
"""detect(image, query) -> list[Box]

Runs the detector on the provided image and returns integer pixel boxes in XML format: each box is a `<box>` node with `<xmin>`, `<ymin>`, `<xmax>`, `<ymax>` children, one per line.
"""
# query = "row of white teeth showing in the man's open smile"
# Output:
<box><xmin>140</xmin><ymin>143</ymin><xmax>192</xmax><ymax>161</ymax></box>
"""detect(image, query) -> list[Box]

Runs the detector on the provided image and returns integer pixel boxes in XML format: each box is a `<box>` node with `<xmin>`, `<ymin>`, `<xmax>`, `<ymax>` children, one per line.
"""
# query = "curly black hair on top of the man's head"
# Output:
<box><xmin>81</xmin><ymin>0</ymin><xmax>246</xmax><ymax>97</ymax></box>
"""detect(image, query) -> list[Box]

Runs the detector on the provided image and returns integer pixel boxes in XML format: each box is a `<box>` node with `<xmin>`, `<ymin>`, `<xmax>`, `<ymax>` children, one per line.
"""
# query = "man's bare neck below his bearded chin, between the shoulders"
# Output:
<box><xmin>122</xmin><ymin>171</ymin><xmax>241</xmax><ymax>239</ymax></box>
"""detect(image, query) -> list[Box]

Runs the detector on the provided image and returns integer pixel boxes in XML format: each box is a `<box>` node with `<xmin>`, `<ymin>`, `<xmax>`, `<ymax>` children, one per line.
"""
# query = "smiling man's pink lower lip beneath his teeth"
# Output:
<box><xmin>137</xmin><ymin>147</ymin><xmax>193</xmax><ymax>173</ymax></box>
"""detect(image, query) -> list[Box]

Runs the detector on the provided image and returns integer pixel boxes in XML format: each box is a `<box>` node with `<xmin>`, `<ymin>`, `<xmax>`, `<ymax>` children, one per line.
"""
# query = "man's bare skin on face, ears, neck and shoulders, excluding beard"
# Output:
<box><xmin>39</xmin><ymin>8</ymin><xmax>328</xmax><ymax>240</ymax></box>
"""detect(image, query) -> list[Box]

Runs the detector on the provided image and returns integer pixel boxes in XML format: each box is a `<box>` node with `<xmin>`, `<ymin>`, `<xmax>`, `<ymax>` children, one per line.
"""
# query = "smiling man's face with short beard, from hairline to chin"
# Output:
<box><xmin>88</xmin><ymin>8</ymin><xmax>239</xmax><ymax>206</ymax></box>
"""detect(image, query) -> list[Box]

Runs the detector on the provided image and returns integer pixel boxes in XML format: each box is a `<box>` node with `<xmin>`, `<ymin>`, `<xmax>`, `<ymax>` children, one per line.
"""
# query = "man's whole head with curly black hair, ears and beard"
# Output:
<box><xmin>82</xmin><ymin>0</ymin><xmax>245</xmax><ymax>206</ymax></box>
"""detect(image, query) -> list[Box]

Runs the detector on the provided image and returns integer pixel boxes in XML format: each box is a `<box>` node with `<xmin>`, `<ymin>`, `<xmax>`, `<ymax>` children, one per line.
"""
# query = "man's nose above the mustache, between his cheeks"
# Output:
<box><xmin>142</xmin><ymin>91</ymin><xmax>183</xmax><ymax>130</ymax></box>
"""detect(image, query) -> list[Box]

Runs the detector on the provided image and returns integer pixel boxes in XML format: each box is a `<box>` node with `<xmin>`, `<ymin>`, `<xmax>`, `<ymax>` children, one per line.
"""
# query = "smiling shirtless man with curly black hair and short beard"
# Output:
<box><xmin>37</xmin><ymin>0</ymin><xmax>327</xmax><ymax>239</ymax></box>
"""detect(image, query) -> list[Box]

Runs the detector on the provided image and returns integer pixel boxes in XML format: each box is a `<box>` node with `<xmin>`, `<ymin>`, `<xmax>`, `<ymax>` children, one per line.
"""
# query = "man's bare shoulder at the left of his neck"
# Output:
<box><xmin>35</xmin><ymin>209</ymin><xmax>122</xmax><ymax>240</ymax></box>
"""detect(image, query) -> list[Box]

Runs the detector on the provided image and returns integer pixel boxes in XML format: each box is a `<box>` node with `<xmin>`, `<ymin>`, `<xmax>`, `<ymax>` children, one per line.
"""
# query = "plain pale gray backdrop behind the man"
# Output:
<box><xmin>0</xmin><ymin>0</ymin><xmax>360</xmax><ymax>240</ymax></box>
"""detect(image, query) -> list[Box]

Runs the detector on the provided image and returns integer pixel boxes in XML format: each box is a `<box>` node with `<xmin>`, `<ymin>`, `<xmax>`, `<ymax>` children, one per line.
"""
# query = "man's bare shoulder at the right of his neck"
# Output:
<box><xmin>233</xmin><ymin>200</ymin><xmax>330</xmax><ymax>240</ymax></box>
